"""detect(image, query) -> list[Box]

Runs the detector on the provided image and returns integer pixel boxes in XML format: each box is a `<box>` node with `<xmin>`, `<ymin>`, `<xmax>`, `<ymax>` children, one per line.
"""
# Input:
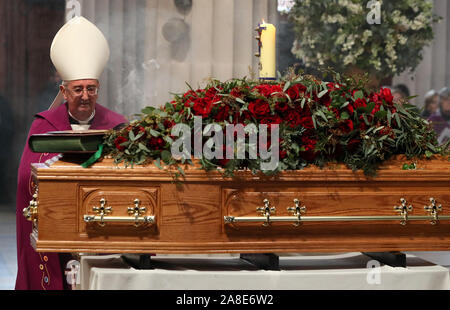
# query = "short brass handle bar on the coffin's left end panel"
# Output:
<box><xmin>83</xmin><ymin>198</ymin><xmax>155</xmax><ymax>227</ymax></box>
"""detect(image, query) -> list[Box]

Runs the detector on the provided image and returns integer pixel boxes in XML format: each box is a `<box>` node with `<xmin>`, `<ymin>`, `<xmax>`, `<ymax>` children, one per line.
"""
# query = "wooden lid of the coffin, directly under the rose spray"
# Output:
<box><xmin>32</xmin><ymin>155</ymin><xmax>450</xmax><ymax>181</ymax></box>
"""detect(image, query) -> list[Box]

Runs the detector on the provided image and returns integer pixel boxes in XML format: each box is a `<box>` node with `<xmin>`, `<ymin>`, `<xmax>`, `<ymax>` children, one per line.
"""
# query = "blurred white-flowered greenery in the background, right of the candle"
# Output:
<box><xmin>288</xmin><ymin>0</ymin><xmax>440</xmax><ymax>79</ymax></box>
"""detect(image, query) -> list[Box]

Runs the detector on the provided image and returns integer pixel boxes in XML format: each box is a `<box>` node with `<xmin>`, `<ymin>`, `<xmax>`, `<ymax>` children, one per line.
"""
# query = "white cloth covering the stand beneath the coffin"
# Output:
<box><xmin>79</xmin><ymin>253</ymin><xmax>450</xmax><ymax>290</ymax></box>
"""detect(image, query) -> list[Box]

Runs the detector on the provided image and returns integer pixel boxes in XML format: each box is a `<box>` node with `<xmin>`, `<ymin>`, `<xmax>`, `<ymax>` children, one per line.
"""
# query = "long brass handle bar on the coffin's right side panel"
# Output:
<box><xmin>224</xmin><ymin>198</ymin><xmax>450</xmax><ymax>226</ymax></box>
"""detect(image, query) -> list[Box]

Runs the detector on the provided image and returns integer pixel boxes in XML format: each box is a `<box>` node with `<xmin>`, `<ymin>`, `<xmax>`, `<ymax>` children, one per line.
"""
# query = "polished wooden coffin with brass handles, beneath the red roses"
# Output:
<box><xmin>25</xmin><ymin>158</ymin><xmax>450</xmax><ymax>253</ymax></box>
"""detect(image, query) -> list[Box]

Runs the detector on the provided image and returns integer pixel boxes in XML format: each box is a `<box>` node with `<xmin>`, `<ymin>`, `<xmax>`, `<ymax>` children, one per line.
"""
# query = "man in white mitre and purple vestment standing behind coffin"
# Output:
<box><xmin>16</xmin><ymin>17</ymin><xmax>127</xmax><ymax>290</ymax></box>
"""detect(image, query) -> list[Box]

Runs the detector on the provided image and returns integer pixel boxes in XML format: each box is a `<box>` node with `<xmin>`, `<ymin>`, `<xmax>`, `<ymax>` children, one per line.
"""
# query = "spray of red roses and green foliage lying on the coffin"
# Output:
<box><xmin>100</xmin><ymin>72</ymin><xmax>443</xmax><ymax>176</ymax></box>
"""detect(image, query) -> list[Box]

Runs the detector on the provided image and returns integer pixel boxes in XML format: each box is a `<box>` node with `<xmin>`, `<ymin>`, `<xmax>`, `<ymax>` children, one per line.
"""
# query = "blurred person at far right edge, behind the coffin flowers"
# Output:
<box><xmin>428</xmin><ymin>87</ymin><xmax>450</xmax><ymax>143</ymax></box>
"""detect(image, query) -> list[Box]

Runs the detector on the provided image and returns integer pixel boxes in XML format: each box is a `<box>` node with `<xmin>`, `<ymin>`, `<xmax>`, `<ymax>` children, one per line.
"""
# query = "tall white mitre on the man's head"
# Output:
<box><xmin>49</xmin><ymin>16</ymin><xmax>109</xmax><ymax>109</ymax></box>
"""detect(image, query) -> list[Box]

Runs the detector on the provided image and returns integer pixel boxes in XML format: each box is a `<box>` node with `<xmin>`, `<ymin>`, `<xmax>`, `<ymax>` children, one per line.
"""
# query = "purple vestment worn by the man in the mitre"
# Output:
<box><xmin>16</xmin><ymin>103</ymin><xmax>128</xmax><ymax>290</ymax></box>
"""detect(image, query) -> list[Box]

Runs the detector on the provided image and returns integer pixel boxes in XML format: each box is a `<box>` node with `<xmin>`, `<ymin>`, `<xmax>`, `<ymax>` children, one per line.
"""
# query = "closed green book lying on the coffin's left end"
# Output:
<box><xmin>28</xmin><ymin>130</ymin><xmax>107</xmax><ymax>153</ymax></box>
